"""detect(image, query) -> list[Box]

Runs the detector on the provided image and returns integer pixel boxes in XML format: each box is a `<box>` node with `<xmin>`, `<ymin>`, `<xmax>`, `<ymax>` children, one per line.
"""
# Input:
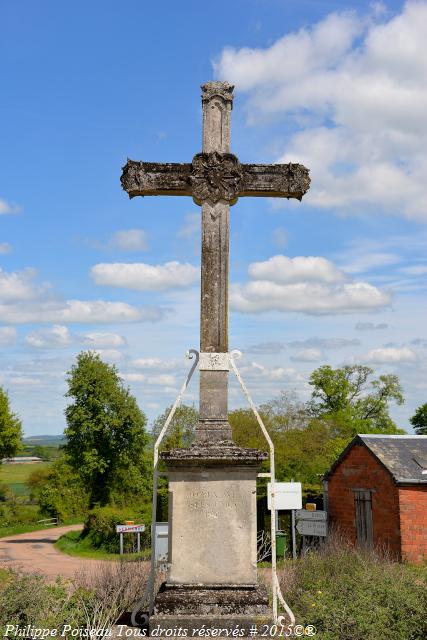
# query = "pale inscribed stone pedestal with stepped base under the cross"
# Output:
<box><xmin>150</xmin><ymin>443</ymin><xmax>270</xmax><ymax>637</ymax></box>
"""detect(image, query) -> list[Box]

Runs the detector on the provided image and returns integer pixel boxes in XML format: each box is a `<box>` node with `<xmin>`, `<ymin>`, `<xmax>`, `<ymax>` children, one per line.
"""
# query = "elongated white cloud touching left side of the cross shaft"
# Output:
<box><xmin>91</xmin><ymin>261</ymin><xmax>199</xmax><ymax>291</ymax></box>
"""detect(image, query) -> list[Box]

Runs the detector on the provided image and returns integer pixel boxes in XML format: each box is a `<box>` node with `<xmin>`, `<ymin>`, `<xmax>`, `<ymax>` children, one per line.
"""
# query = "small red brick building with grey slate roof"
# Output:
<box><xmin>324</xmin><ymin>435</ymin><xmax>427</xmax><ymax>563</ymax></box>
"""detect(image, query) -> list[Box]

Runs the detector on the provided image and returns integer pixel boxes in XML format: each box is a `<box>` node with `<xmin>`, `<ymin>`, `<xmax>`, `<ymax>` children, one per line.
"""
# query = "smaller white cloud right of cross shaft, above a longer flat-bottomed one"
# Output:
<box><xmin>248</xmin><ymin>255</ymin><xmax>345</xmax><ymax>284</ymax></box>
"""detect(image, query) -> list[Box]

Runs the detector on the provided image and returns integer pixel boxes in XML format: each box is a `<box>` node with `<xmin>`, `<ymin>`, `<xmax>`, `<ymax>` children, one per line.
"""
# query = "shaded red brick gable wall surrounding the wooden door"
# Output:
<box><xmin>328</xmin><ymin>444</ymin><xmax>401</xmax><ymax>558</ymax></box>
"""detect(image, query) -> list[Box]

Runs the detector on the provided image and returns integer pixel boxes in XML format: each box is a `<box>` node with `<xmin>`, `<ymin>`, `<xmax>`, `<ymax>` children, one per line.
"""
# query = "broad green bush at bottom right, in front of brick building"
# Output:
<box><xmin>280</xmin><ymin>545</ymin><xmax>427</xmax><ymax>640</ymax></box>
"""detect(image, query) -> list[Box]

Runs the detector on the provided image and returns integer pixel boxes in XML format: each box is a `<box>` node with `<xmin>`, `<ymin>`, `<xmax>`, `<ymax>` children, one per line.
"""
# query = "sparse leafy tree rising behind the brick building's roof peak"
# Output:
<box><xmin>308</xmin><ymin>365</ymin><xmax>404</xmax><ymax>437</ymax></box>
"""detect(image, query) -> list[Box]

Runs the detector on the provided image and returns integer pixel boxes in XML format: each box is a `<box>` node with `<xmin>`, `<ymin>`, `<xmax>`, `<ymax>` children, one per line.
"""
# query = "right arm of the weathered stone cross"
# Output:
<box><xmin>239</xmin><ymin>163</ymin><xmax>310</xmax><ymax>200</ymax></box>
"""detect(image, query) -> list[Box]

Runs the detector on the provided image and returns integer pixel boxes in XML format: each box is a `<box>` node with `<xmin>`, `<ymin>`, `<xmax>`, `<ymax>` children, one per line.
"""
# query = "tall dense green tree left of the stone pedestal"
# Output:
<box><xmin>64</xmin><ymin>351</ymin><xmax>148</xmax><ymax>507</ymax></box>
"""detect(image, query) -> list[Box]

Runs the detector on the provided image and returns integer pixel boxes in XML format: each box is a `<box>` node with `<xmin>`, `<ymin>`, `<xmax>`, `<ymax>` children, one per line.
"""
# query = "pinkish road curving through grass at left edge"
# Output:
<box><xmin>0</xmin><ymin>524</ymin><xmax>106</xmax><ymax>578</ymax></box>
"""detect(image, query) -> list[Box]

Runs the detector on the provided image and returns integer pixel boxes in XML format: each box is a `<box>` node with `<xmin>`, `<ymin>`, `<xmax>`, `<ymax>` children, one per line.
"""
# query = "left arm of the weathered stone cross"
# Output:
<box><xmin>120</xmin><ymin>159</ymin><xmax>192</xmax><ymax>198</ymax></box>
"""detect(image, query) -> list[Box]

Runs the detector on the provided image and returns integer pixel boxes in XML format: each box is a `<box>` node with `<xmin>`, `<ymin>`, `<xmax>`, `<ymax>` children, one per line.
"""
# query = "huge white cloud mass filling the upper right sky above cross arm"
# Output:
<box><xmin>215</xmin><ymin>2</ymin><xmax>427</xmax><ymax>221</ymax></box>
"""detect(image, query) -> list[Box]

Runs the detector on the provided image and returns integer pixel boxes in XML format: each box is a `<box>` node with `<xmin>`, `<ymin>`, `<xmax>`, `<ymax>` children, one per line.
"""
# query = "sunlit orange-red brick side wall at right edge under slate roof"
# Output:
<box><xmin>399</xmin><ymin>485</ymin><xmax>427</xmax><ymax>564</ymax></box>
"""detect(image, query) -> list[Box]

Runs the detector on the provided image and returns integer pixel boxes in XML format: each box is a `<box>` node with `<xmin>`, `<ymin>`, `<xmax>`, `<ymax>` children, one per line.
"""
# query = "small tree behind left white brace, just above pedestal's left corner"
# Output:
<box><xmin>151</xmin><ymin>404</ymin><xmax>199</xmax><ymax>450</ymax></box>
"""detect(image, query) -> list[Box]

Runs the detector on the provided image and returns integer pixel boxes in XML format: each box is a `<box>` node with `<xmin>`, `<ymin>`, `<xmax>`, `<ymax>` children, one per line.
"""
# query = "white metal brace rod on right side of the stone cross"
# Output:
<box><xmin>229</xmin><ymin>349</ymin><xmax>295</xmax><ymax>625</ymax></box>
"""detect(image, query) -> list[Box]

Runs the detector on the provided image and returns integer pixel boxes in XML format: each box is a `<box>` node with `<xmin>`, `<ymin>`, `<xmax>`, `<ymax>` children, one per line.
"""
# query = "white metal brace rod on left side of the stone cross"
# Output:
<box><xmin>131</xmin><ymin>349</ymin><xmax>199</xmax><ymax>626</ymax></box>
